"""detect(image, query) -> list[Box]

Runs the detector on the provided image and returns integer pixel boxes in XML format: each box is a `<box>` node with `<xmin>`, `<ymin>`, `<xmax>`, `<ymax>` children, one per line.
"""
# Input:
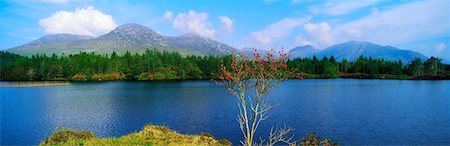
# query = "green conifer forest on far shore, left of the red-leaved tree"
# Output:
<box><xmin>0</xmin><ymin>50</ymin><xmax>227</xmax><ymax>81</ymax></box>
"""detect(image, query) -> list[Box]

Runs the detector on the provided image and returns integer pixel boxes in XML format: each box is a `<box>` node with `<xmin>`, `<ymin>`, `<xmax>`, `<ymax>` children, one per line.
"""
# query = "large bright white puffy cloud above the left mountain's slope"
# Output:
<box><xmin>39</xmin><ymin>6</ymin><xmax>117</xmax><ymax>36</ymax></box>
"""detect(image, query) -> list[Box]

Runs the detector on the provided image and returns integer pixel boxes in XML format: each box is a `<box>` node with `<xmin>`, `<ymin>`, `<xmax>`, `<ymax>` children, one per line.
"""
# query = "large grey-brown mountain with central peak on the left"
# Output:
<box><xmin>7</xmin><ymin>23</ymin><xmax>237</xmax><ymax>56</ymax></box>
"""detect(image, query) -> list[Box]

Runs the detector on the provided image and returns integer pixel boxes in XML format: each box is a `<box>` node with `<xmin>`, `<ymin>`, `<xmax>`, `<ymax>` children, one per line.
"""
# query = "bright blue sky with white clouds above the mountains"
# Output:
<box><xmin>0</xmin><ymin>0</ymin><xmax>450</xmax><ymax>60</ymax></box>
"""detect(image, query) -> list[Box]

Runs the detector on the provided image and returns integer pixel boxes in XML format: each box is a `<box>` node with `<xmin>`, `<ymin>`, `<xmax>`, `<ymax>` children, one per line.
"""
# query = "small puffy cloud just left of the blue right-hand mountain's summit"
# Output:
<box><xmin>303</xmin><ymin>22</ymin><xmax>335</xmax><ymax>49</ymax></box>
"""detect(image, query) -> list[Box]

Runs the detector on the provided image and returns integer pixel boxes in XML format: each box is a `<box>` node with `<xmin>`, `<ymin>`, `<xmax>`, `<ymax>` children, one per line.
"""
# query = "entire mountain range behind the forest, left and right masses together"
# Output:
<box><xmin>6</xmin><ymin>23</ymin><xmax>427</xmax><ymax>63</ymax></box>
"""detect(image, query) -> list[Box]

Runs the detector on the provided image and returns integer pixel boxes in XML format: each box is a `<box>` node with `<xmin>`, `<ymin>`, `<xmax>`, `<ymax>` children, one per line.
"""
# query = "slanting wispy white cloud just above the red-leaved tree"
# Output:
<box><xmin>244</xmin><ymin>17</ymin><xmax>310</xmax><ymax>48</ymax></box>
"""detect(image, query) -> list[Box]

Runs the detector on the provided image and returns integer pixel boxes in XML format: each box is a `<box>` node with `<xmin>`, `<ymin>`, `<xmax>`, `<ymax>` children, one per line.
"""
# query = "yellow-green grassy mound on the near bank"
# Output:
<box><xmin>40</xmin><ymin>124</ymin><xmax>231</xmax><ymax>146</ymax></box>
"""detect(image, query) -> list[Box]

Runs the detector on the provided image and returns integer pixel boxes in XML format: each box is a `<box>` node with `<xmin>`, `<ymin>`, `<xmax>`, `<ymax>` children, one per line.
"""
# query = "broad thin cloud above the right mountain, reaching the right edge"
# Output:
<box><xmin>332</xmin><ymin>0</ymin><xmax>450</xmax><ymax>45</ymax></box>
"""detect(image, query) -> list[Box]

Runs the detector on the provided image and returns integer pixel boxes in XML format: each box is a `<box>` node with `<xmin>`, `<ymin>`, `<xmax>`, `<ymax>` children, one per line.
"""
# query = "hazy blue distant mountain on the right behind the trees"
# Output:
<box><xmin>291</xmin><ymin>41</ymin><xmax>428</xmax><ymax>63</ymax></box>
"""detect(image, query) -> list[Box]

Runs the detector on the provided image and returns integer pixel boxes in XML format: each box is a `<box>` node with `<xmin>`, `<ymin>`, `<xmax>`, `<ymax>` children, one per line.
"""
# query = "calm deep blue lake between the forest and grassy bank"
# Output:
<box><xmin>0</xmin><ymin>79</ymin><xmax>450</xmax><ymax>145</ymax></box>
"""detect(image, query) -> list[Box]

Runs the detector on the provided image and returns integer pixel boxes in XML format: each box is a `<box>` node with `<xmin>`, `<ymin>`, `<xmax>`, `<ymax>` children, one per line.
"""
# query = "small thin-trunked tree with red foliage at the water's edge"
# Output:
<box><xmin>217</xmin><ymin>50</ymin><xmax>296</xmax><ymax>146</ymax></box>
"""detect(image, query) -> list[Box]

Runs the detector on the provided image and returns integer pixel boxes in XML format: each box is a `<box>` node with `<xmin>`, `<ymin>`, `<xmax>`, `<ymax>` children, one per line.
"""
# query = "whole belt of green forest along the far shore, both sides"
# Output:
<box><xmin>0</xmin><ymin>50</ymin><xmax>450</xmax><ymax>81</ymax></box>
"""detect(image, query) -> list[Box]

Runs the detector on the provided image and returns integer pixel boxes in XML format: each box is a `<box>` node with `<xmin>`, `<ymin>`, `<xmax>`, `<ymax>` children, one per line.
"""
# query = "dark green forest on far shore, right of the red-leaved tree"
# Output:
<box><xmin>287</xmin><ymin>56</ymin><xmax>450</xmax><ymax>79</ymax></box>
